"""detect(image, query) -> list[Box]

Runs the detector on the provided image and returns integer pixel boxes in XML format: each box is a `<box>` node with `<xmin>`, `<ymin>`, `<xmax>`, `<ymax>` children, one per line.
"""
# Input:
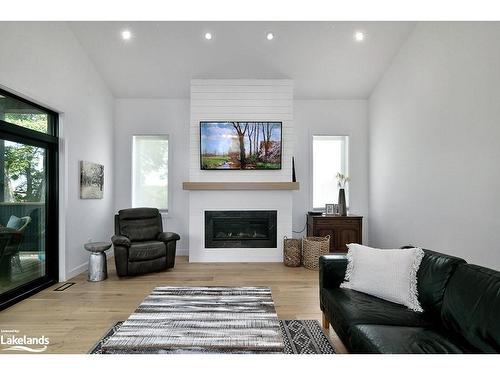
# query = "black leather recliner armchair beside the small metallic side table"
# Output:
<box><xmin>111</xmin><ymin>207</ymin><xmax>180</xmax><ymax>276</ymax></box>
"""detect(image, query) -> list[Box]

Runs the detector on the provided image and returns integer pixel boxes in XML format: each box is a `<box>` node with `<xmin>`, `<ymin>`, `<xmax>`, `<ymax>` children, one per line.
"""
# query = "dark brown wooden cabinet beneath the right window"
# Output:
<box><xmin>307</xmin><ymin>214</ymin><xmax>363</xmax><ymax>253</ymax></box>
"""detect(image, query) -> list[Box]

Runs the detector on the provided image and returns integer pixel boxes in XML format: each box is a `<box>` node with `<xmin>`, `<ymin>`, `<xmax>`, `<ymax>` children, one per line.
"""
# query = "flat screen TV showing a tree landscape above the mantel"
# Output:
<box><xmin>200</xmin><ymin>121</ymin><xmax>282</xmax><ymax>170</ymax></box>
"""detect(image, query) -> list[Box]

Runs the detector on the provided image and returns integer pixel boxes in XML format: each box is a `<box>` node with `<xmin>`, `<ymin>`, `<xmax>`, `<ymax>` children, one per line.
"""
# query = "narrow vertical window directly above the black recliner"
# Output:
<box><xmin>132</xmin><ymin>135</ymin><xmax>168</xmax><ymax>212</ymax></box>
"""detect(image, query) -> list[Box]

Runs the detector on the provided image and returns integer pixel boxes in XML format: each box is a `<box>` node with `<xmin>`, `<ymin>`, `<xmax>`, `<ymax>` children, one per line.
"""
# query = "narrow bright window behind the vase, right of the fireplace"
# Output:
<box><xmin>313</xmin><ymin>135</ymin><xmax>349</xmax><ymax>209</ymax></box>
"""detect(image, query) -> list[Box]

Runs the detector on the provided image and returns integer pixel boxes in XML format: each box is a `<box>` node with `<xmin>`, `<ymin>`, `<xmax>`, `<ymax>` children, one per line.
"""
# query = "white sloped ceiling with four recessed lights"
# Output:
<box><xmin>69</xmin><ymin>22</ymin><xmax>415</xmax><ymax>99</ymax></box>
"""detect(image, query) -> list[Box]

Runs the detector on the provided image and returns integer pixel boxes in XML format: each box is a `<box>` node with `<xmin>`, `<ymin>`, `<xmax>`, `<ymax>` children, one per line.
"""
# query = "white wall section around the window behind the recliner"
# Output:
<box><xmin>115</xmin><ymin>99</ymin><xmax>190</xmax><ymax>255</ymax></box>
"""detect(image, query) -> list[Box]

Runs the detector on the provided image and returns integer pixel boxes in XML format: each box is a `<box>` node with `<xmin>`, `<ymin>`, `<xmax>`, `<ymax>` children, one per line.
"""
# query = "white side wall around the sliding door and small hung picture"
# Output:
<box><xmin>0</xmin><ymin>22</ymin><xmax>114</xmax><ymax>280</ymax></box>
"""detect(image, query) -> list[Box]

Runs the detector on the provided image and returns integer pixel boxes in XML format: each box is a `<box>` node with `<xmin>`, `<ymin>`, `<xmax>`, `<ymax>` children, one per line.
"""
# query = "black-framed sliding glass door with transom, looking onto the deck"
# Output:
<box><xmin>0</xmin><ymin>90</ymin><xmax>58</xmax><ymax>309</ymax></box>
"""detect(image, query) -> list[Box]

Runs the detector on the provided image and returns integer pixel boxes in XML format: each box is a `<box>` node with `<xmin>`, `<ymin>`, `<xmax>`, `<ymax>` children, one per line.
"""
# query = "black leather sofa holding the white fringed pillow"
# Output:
<box><xmin>319</xmin><ymin>250</ymin><xmax>500</xmax><ymax>354</ymax></box>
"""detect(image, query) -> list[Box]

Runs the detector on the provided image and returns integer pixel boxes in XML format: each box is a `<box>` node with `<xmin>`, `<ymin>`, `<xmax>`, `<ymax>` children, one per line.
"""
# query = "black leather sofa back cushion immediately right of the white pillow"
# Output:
<box><xmin>417</xmin><ymin>249</ymin><xmax>465</xmax><ymax>320</ymax></box>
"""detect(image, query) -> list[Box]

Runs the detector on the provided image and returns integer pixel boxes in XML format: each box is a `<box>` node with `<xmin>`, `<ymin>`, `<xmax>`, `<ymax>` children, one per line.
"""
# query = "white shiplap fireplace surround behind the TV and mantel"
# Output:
<box><xmin>189</xmin><ymin>79</ymin><xmax>294</xmax><ymax>262</ymax></box>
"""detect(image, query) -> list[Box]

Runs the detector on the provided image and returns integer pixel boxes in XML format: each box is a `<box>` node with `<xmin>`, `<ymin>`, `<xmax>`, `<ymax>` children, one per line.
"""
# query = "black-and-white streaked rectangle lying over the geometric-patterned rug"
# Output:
<box><xmin>101</xmin><ymin>287</ymin><xmax>283</xmax><ymax>354</ymax></box>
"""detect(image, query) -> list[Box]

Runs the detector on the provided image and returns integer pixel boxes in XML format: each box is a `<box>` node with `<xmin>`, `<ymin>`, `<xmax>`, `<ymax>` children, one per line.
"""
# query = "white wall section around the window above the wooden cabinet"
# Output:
<box><xmin>293</xmin><ymin>100</ymin><xmax>369</xmax><ymax>243</ymax></box>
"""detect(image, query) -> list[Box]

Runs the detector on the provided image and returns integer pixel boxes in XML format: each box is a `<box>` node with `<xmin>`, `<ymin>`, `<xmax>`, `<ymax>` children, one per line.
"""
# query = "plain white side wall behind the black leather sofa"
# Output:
<box><xmin>369</xmin><ymin>22</ymin><xmax>500</xmax><ymax>269</ymax></box>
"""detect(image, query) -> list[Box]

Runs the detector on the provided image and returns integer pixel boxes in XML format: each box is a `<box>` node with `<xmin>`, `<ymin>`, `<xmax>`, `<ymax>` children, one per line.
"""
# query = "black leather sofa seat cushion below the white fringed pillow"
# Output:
<box><xmin>321</xmin><ymin>288</ymin><xmax>432</xmax><ymax>341</ymax></box>
